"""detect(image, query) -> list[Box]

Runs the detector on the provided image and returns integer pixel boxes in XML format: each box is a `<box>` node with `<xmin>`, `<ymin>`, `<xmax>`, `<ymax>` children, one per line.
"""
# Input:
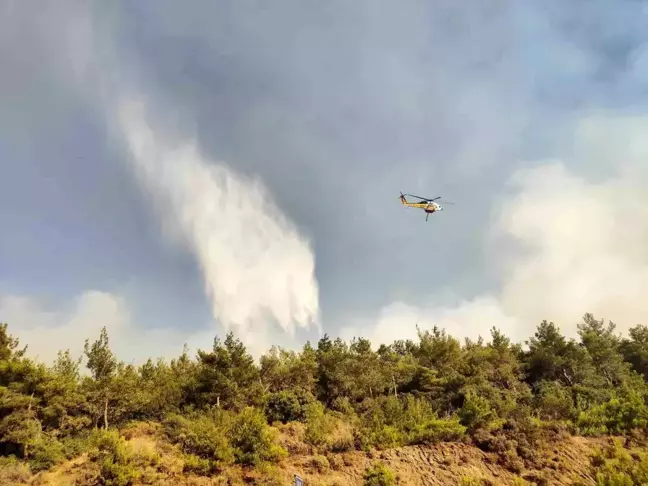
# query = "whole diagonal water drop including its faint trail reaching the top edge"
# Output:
<box><xmin>1</xmin><ymin>0</ymin><xmax>319</xmax><ymax>356</ymax></box>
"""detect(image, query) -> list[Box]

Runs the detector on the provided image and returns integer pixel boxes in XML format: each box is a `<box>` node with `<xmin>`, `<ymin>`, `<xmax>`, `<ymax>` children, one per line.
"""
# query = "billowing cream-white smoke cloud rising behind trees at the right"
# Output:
<box><xmin>344</xmin><ymin>116</ymin><xmax>648</xmax><ymax>344</ymax></box>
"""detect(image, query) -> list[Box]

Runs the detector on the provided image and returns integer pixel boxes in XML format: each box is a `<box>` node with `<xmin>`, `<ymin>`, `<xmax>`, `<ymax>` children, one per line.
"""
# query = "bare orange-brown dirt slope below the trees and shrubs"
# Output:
<box><xmin>16</xmin><ymin>430</ymin><xmax>603</xmax><ymax>486</ymax></box>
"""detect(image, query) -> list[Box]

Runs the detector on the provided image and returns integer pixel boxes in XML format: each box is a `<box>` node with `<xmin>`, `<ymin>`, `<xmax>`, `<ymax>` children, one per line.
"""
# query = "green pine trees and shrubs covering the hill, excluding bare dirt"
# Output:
<box><xmin>0</xmin><ymin>314</ymin><xmax>648</xmax><ymax>484</ymax></box>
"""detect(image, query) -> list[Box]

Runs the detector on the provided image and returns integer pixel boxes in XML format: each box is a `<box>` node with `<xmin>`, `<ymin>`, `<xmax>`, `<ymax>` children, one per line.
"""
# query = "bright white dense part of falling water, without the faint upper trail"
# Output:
<box><xmin>117</xmin><ymin>101</ymin><xmax>319</xmax><ymax>347</ymax></box>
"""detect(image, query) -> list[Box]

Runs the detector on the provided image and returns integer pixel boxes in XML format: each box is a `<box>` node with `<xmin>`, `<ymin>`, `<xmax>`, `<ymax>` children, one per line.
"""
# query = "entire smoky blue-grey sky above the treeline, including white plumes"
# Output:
<box><xmin>0</xmin><ymin>0</ymin><xmax>648</xmax><ymax>361</ymax></box>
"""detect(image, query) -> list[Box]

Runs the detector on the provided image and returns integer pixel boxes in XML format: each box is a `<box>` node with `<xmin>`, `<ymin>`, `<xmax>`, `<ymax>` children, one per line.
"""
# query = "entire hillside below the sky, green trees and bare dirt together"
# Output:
<box><xmin>0</xmin><ymin>314</ymin><xmax>648</xmax><ymax>486</ymax></box>
